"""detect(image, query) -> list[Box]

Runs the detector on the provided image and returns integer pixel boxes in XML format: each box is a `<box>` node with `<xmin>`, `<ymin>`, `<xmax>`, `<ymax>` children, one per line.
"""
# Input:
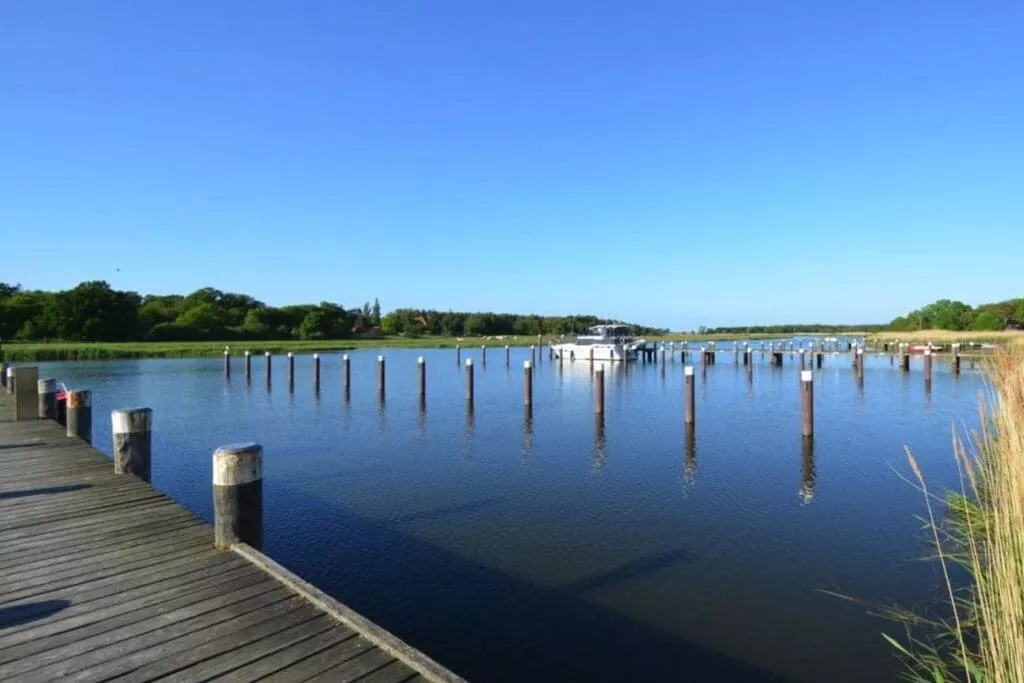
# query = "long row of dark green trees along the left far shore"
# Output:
<box><xmin>0</xmin><ymin>282</ymin><xmax>654</xmax><ymax>342</ymax></box>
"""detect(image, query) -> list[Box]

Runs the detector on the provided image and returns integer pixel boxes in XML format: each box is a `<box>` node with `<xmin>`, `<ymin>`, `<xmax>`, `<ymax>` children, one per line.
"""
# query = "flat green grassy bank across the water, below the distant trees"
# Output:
<box><xmin>3</xmin><ymin>334</ymin><xmax>872</xmax><ymax>362</ymax></box>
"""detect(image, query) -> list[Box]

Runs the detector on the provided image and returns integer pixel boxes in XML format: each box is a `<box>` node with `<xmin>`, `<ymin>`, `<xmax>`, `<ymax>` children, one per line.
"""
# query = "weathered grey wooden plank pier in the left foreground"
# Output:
<box><xmin>0</xmin><ymin>395</ymin><xmax>462</xmax><ymax>683</ymax></box>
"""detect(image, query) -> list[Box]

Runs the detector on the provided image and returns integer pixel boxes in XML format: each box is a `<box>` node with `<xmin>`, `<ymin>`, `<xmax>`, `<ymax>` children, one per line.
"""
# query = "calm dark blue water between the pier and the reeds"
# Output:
<box><xmin>40</xmin><ymin>348</ymin><xmax>984</xmax><ymax>681</ymax></box>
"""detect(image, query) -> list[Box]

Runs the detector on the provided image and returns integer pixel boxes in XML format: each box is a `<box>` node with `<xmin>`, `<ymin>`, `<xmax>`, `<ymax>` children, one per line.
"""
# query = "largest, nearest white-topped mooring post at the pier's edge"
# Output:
<box><xmin>213</xmin><ymin>443</ymin><xmax>263</xmax><ymax>550</ymax></box>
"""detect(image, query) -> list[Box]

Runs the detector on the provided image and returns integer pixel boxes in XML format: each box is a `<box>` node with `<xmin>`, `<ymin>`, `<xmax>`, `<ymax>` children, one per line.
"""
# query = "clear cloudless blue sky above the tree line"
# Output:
<box><xmin>0</xmin><ymin>0</ymin><xmax>1024</xmax><ymax>329</ymax></box>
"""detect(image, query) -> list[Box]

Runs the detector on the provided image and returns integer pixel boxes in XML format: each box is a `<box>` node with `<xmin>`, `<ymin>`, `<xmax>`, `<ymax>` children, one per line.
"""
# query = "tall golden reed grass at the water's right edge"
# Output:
<box><xmin>886</xmin><ymin>346</ymin><xmax>1024</xmax><ymax>683</ymax></box>
